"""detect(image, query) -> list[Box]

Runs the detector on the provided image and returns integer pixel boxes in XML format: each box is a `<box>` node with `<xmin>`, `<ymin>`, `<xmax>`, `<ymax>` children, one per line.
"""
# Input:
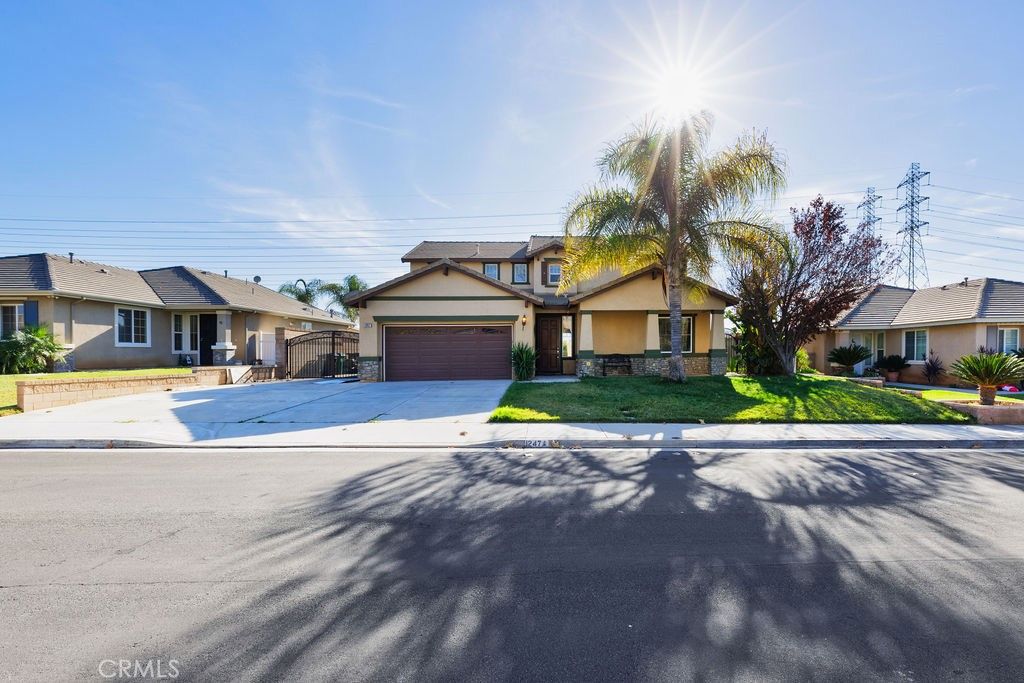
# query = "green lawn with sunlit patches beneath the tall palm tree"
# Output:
<box><xmin>490</xmin><ymin>375</ymin><xmax>971</xmax><ymax>423</ymax></box>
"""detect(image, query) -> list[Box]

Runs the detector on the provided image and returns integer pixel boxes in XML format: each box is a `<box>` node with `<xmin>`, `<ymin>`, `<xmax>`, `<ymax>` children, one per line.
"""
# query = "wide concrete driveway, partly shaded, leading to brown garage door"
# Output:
<box><xmin>3</xmin><ymin>380</ymin><xmax>510</xmax><ymax>435</ymax></box>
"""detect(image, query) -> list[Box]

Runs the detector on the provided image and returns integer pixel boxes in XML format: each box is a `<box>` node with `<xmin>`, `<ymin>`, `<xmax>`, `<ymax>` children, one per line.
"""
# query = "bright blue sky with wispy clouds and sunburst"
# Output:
<box><xmin>0</xmin><ymin>2</ymin><xmax>1024</xmax><ymax>294</ymax></box>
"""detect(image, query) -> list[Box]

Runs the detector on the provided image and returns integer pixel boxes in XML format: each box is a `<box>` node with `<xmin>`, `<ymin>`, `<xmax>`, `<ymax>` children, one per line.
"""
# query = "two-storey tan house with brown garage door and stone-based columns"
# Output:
<box><xmin>346</xmin><ymin>237</ymin><xmax>736</xmax><ymax>381</ymax></box>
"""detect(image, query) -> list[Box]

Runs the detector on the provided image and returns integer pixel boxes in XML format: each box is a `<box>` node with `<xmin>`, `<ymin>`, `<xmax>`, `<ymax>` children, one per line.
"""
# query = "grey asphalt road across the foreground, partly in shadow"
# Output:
<box><xmin>0</xmin><ymin>451</ymin><xmax>1024</xmax><ymax>681</ymax></box>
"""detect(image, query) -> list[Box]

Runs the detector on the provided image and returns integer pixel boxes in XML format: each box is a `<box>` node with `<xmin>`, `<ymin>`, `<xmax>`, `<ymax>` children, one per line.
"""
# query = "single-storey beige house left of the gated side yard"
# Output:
<box><xmin>0</xmin><ymin>254</ymin><xmax>353</xmax><ymax>370</ymax></box>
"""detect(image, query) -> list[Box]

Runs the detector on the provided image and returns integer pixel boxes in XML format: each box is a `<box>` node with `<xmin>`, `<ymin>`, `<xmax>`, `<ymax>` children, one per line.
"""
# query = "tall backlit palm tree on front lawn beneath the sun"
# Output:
<box><xmin>562</xmin><ymin>112</ymin><xmax>785</xmax><ymax>381</ymax></box>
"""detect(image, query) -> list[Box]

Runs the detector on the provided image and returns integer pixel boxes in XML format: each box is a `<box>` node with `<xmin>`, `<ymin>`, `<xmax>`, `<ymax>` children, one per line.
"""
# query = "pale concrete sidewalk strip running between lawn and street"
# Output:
<box><xmin>0</xmin><ymin>421</ymin><xmax>1024</xmax><ymax>449</ymax></box>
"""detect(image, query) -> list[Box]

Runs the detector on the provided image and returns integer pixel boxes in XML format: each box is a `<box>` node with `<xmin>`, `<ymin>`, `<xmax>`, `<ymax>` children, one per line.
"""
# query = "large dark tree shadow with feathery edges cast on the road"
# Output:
<box><xmin>155</xmin><ymin>451</ymin><xmax>1024</xmax><ymax>681</ymax></box>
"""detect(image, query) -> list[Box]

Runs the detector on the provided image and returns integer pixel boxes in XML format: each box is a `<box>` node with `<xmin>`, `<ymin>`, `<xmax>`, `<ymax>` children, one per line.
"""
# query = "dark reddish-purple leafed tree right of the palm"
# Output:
<box><xmin>730</xmin><ymin>196</ymin><xmax>894</xmax><ymax>375</ymax></box>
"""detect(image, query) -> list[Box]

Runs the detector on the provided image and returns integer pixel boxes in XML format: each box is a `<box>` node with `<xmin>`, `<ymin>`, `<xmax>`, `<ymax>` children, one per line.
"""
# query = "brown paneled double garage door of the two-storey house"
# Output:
<box><xmin>384</xmin><ymin>326</ymin><xmax>512</xmax><ymax>381</ymax></box>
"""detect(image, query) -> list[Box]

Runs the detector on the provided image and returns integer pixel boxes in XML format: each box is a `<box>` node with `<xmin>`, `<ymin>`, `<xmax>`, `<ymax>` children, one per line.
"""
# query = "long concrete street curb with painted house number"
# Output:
<box><xmin>0</xmin><ymin>438</ymin><xmax>1024</xmax><ymax>451</ymax></box>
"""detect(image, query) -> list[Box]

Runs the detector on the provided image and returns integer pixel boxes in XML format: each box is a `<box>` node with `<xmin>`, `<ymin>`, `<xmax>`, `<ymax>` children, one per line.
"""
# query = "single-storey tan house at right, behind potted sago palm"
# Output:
<box><xmin>806</xmin><ymin>278</ymin><xmax>1024</xmax><ymax>383</ymax></box>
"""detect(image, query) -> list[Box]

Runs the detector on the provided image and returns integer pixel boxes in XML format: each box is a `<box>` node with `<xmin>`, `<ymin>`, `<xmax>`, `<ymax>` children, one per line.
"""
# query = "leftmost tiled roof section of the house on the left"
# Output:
<box><xmin>0</xmin><ymin>254</ymin><xmax>163</xmax><ymax>306</ymax></box>
